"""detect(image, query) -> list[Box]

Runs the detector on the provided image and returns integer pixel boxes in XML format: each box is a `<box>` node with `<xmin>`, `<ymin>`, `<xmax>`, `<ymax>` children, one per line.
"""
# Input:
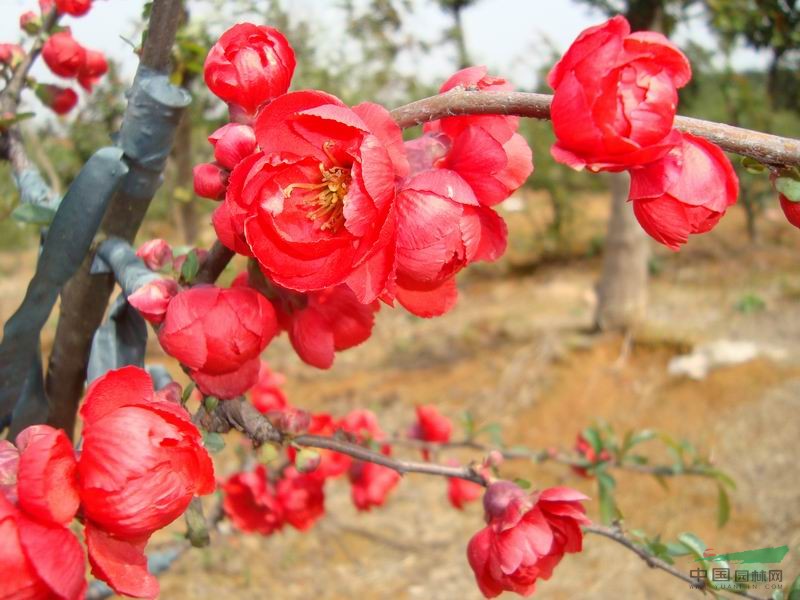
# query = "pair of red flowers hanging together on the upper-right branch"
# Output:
<box><xmin>548</xmin><ymin>16</ymin><xmax>739</xmax><ymax>250</ymax></box>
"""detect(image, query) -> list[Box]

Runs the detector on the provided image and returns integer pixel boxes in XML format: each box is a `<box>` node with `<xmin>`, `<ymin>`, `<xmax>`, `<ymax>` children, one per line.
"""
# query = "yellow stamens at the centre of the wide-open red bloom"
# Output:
<box><xmin>283</xmin><ymin>141</ymin><xmax>351</xmax><ymax>233</ymax></box>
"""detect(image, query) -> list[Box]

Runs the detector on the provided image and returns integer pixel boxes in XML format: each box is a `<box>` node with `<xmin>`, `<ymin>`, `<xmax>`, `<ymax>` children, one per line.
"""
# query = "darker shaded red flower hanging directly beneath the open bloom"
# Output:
<box><xmin>276</xmin><ymin>285</ymin><xmax>380</xmax><ymax>369</ymax></box>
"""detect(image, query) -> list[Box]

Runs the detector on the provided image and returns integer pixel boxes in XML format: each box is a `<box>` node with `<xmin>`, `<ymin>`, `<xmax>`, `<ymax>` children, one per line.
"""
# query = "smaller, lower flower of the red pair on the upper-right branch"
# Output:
<box><xmin>630</xmin><ymin>133</ymin><xmax>739</xmax><ymax>250</ymax></box>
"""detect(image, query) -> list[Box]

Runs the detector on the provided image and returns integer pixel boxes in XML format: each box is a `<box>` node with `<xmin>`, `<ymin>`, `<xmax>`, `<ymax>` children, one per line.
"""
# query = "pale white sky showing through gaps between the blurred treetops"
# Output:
<box><xmin>0</xmin><ymin>0</ymin><xmax>766</xmax><ymax>115</ymax></box>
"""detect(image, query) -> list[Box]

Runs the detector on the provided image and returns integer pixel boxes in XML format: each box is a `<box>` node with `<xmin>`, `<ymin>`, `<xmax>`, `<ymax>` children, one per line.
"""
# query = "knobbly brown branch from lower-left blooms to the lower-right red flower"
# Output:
<box><xmin>198</xmin><ymin>399</ymin><xmax>488</xmax><ymax>486</ymax></box>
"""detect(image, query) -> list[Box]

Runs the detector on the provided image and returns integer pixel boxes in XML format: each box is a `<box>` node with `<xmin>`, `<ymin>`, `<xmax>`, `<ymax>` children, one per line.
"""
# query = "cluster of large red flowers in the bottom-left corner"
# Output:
<box><xmin>0</xmin><ymin>367</ymin><xmax>215</xmax><ymax>600</ymax></box>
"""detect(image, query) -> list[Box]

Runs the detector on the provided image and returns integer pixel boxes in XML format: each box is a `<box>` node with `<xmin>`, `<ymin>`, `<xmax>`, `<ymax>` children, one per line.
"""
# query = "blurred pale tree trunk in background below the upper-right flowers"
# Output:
<box><xmin>594</xmin><ymin>173</ymin><xmax>650</xmax><ymax>331</ymax></box>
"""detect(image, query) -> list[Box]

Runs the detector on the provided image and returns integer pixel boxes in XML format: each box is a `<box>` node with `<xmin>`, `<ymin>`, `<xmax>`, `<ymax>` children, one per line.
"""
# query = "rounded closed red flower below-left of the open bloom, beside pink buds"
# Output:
<box><xmin>158</xmin><ymin>286</ymin><xmax>278</xmax><ymax>399</ymax></box>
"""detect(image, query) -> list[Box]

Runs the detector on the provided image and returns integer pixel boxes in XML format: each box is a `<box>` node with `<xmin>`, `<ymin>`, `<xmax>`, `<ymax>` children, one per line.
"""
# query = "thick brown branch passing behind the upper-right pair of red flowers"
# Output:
<box><xmin>391</xmin><ymin>88</ymin><xmax>800</xmax><ymax>166</ymax></box>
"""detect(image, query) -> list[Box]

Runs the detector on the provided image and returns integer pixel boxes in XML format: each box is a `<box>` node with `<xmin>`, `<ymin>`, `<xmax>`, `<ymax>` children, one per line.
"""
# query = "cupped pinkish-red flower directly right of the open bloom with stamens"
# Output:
<box><xmin>397</xmin><ymin>169</ymin><xmax>508</xmax><ymax>317</ymax></box>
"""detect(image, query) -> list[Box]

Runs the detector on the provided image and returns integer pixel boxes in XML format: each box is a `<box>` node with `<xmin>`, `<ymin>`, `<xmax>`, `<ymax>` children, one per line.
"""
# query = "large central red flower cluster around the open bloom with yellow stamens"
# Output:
<box><xmin>177</xmin><ymin>23</ymin><xmax>533</xmax><ymax>384</ymax></box>
